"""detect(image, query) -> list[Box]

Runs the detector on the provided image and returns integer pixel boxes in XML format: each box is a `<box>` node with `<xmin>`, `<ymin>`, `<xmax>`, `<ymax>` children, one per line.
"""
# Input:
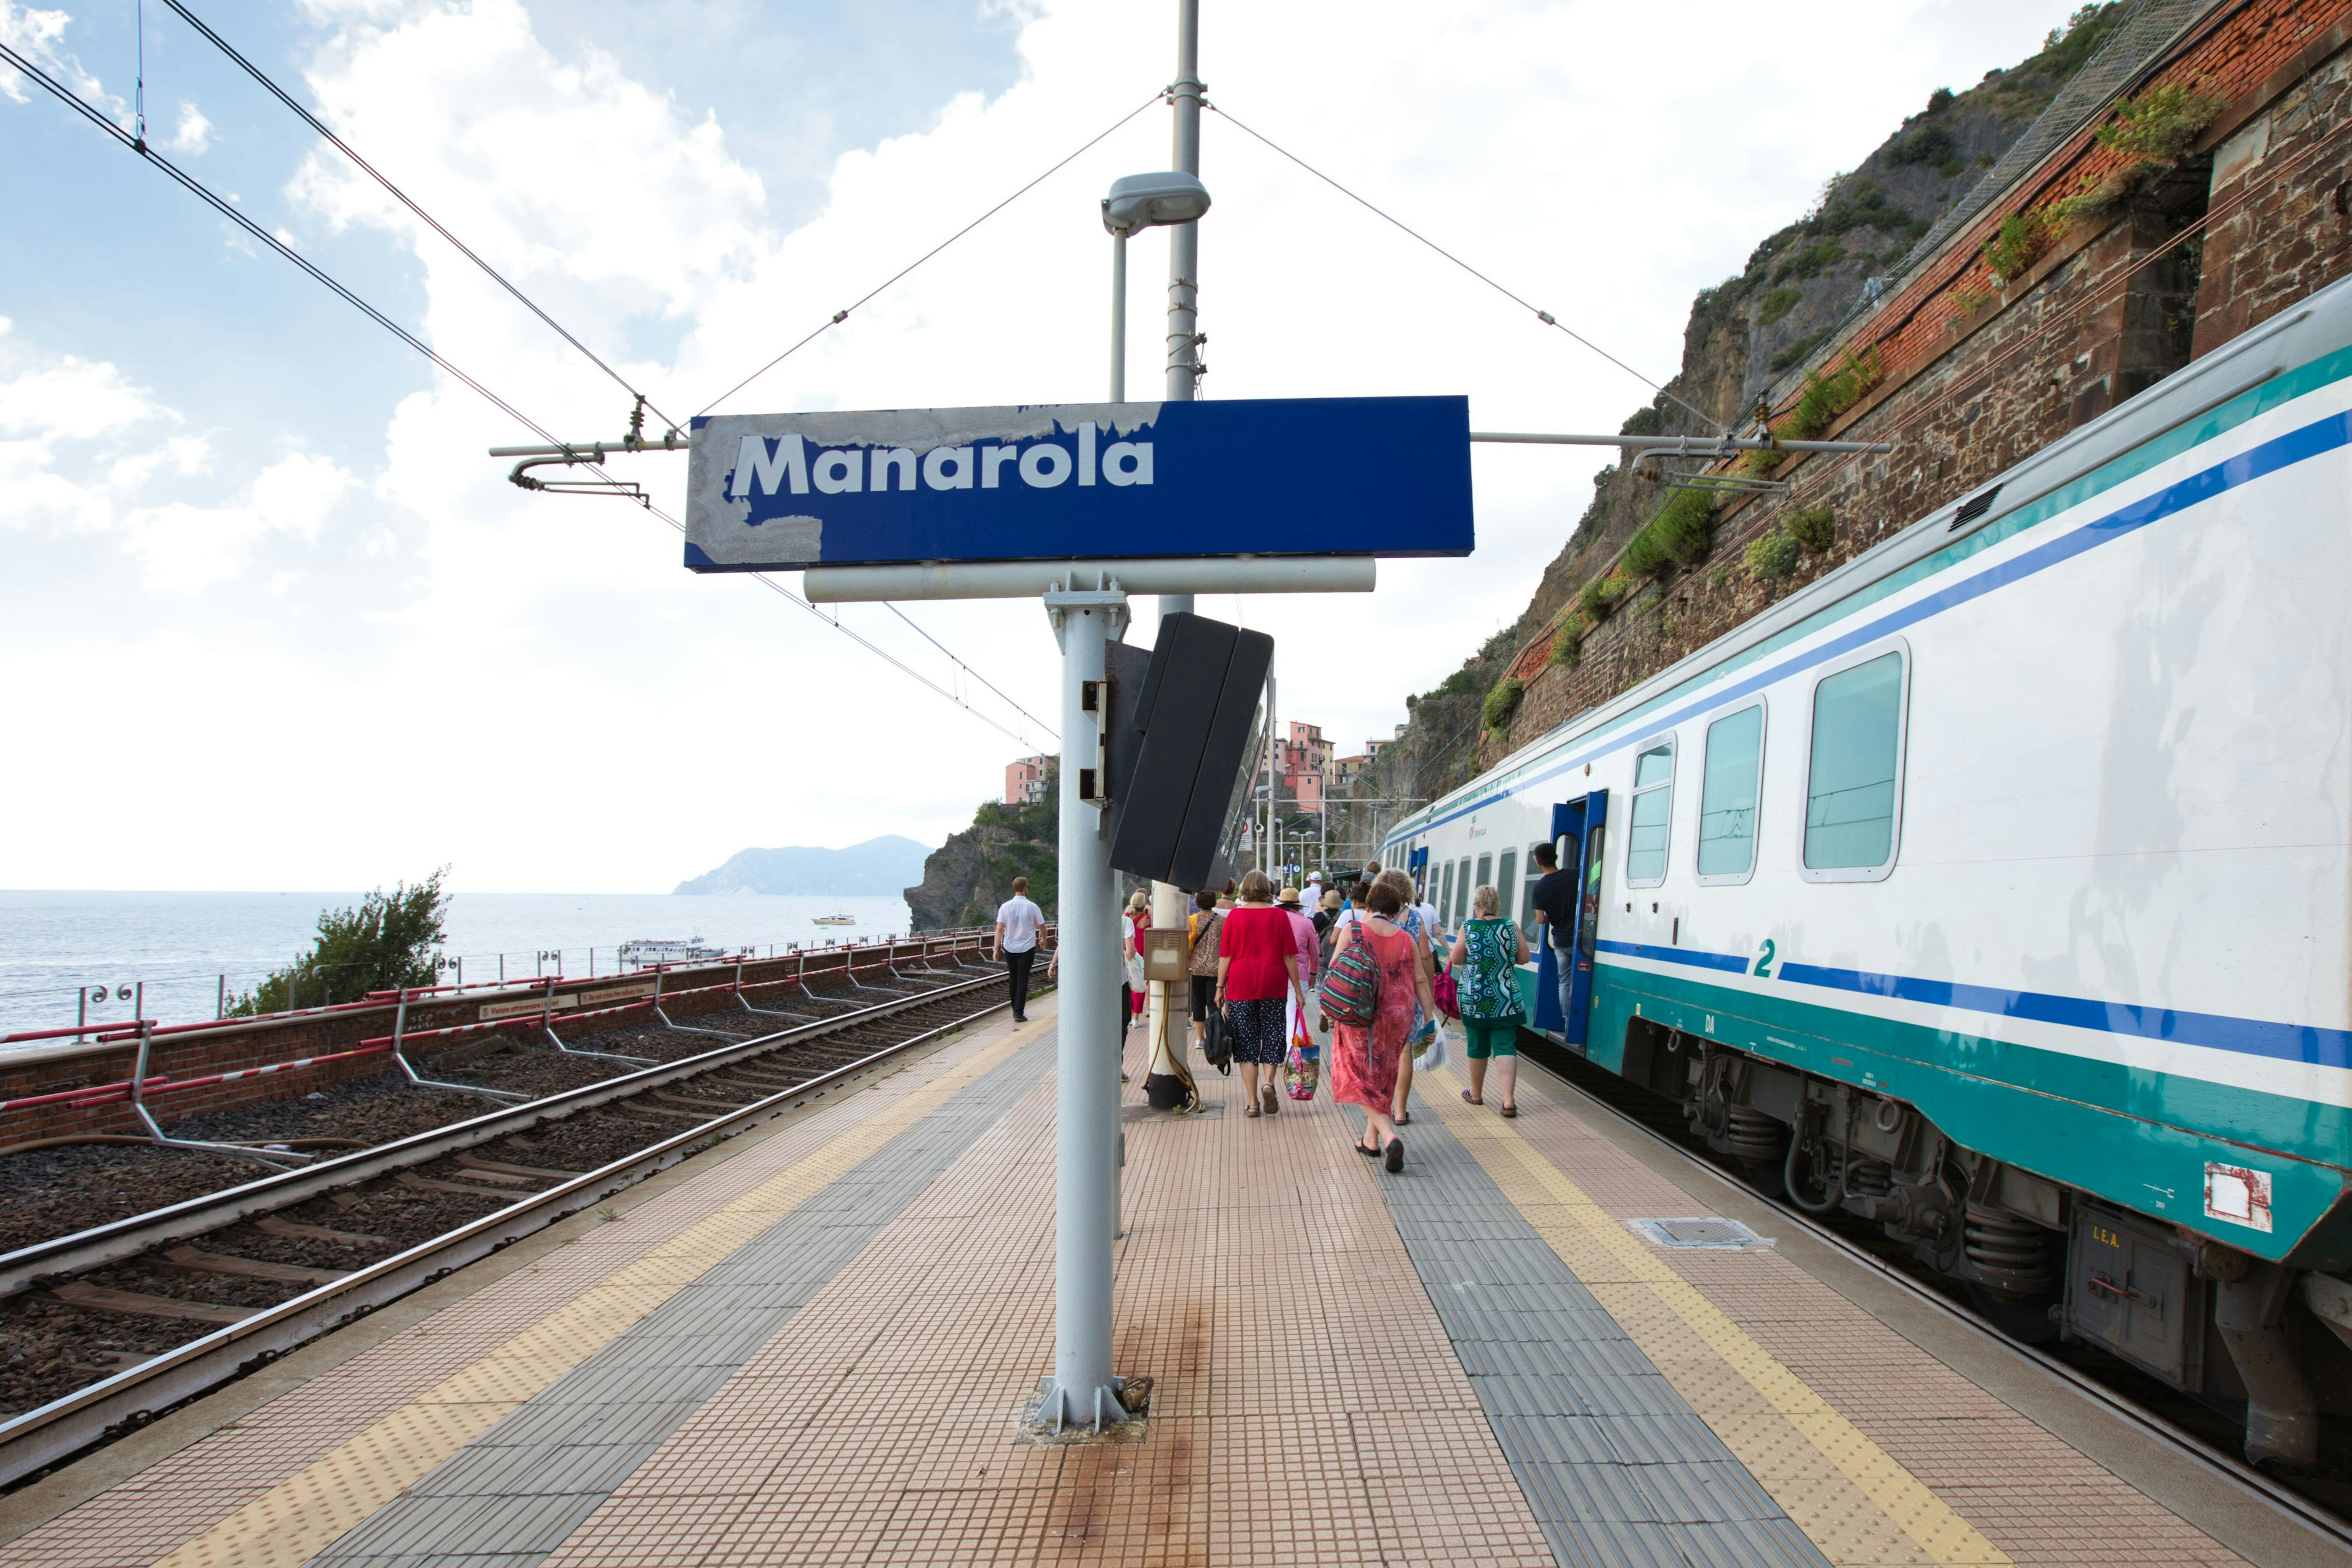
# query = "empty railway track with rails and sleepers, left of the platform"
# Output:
<box><xmin>0</xmin><ymin>966</ymin><xmax>1035</xmax><ymax>1490</ymax></box>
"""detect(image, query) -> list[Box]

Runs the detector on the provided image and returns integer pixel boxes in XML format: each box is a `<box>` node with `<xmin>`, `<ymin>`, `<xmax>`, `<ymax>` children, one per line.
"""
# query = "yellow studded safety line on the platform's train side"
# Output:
<box><xmin>1428</xmin><ymin>1069</ymin><xmax>2008</xmax><ymax>1568</ymax></box>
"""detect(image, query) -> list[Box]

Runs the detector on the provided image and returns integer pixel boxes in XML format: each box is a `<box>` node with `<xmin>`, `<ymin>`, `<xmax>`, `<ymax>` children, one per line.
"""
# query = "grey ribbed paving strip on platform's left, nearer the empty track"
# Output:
<box><xmin>311</xmin><ymin>1035</ymin><xmax>1054</xmax><ymax>1568</ymax></box>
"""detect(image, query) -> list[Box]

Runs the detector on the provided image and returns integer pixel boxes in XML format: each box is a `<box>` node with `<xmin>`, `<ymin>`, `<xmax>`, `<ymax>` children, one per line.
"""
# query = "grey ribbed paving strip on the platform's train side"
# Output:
<box><xmin>1381</xmin><ymin>1114</ymin><xmax>1828</xmax><ymax>1568</ymax></box>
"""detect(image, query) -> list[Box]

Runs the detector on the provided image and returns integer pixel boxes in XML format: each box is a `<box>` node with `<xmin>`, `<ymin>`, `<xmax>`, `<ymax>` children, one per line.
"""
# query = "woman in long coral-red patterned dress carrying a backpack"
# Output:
<box><xmin>1322</xmin><ymin>879</ymin><xmax>1437</xmax><ymax>1173</ymax></box>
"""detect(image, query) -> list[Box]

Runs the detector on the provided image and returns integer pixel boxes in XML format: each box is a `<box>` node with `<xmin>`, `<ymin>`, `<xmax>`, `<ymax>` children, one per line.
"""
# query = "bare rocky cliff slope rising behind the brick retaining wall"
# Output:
<box><xmin>1345</xmin><ymin>5</ymin><xmax>2126</xmax><ymax>844</ymax></box>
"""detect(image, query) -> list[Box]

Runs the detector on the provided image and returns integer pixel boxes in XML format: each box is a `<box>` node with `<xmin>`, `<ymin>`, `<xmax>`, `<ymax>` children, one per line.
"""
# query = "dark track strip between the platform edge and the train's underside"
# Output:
<box><xmin>1520</xmin><ymin>1032</ymin><xmax>2352</xmax><ymax>1551</ymax></box>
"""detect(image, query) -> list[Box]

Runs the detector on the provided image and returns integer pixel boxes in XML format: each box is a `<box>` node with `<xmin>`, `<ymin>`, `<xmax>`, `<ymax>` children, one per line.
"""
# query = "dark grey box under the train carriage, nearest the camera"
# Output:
<box><xmin>2067</xmin><ymin>1204</ymin><xmax>2206</xmax><ymax>1394</ymax></box>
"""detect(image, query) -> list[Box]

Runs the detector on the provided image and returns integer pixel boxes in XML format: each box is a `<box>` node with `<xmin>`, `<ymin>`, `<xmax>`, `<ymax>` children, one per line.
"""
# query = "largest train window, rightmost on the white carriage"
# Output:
<box><xmin>1804</xmin><ymin>646</ymin><xmax>1910</xmax><ymax>881</ymax></box>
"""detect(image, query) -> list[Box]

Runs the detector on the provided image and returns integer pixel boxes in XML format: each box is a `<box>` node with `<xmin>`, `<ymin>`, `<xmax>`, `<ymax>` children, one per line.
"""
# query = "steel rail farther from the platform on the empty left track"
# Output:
<box><xmin>0</xmin><ymin>980</ymin><xmax>988</xmax><ymax>1298</ymax></box>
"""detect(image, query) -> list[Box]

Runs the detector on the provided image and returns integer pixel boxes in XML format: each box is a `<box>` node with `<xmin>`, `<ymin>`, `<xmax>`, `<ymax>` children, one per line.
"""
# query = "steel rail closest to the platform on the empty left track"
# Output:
<box><xmin>0</xmin><ymin>980</ymin><xmax>1007</xmax><ymax>1488</ymax></box>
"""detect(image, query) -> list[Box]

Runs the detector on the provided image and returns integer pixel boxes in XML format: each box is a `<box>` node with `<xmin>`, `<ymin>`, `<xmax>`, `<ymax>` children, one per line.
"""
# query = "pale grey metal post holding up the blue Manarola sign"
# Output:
<box><xmin>1037</xmin><ymin>590</ymin><xmax>1126</xmax><ymax>1431</ymax></box>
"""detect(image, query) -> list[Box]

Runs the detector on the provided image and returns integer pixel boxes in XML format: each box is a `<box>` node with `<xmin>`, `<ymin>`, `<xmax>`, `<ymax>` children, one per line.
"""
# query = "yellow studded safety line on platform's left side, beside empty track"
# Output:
<box><xmin>155</xmin><ymin>1018</ymin><xmax>1047</xmax><ymax>1568</ymax></box>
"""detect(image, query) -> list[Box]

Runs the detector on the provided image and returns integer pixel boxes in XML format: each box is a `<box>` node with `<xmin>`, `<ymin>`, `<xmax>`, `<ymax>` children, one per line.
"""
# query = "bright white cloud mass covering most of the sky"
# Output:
<box><xmin>0</xmin><ymin>0</ymin><xmax>2053</xmax><ymax>889</ymax></box>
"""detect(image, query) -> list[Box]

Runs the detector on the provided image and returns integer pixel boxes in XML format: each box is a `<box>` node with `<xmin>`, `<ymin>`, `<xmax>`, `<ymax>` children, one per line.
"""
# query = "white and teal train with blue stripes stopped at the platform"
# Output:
<box><xmin>1381</xmin><ymin>282</ymin><xmax>2352</xmax><ymax>1469</ymax></box>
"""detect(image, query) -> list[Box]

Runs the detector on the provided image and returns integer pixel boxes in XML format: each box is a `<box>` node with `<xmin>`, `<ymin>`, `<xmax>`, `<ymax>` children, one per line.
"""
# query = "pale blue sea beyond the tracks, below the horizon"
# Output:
<box><xmin>0</xmin><ymin>891</ymin><xmax>910</xmax><ymax>1049</ymax></box>
